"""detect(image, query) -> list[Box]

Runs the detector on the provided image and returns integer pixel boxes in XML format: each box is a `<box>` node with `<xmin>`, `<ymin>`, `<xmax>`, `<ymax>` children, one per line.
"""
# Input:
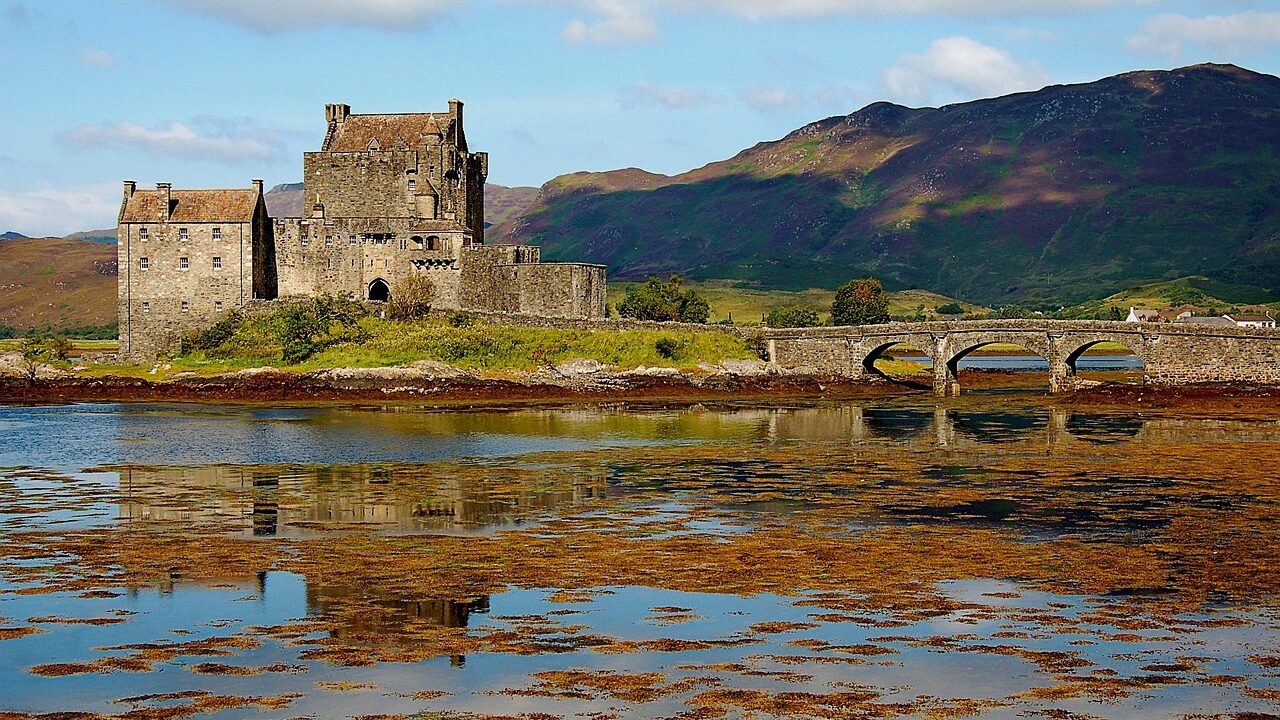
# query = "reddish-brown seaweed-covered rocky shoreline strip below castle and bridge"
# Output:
<box><xmin>0</xmin><ymin>369</ymin><xmax>1280</xmax><ymax>413</ymax></box>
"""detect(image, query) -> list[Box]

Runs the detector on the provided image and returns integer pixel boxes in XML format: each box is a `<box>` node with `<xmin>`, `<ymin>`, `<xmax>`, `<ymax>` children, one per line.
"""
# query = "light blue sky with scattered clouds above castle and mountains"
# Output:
<box><xmin>0</xmin><ymin>0</ymin><xmax>1280</xmax><ymax>236</ymax></box>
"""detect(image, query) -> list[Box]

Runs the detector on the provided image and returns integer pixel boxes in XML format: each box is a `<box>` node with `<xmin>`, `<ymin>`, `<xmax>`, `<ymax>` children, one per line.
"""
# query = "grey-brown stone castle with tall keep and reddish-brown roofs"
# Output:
<box><xmin>118</xmin><ymin>100</ymin><xmax>605</xmax><ymax>356</ymax></box>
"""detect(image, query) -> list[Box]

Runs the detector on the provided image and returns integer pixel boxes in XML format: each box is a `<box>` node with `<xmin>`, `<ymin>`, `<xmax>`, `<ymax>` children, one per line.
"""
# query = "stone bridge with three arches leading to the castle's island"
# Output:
<box><xmin>764</xmin><ymin>320</ymin><xmax>1280</xmax><ymax>396</ymax></box>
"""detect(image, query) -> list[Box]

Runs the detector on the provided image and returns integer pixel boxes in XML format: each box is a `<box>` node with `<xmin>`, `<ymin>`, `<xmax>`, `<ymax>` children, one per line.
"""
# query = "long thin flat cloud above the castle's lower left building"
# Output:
<box><xmin>59</xmin><ymin>118</ymin><xmax>283</xmax><ymax>164</ymax></box>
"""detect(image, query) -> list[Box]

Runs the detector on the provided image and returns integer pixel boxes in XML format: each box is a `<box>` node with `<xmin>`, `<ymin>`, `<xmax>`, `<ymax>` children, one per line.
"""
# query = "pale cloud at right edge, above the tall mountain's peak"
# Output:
<box><xmin>1129</xmin><ymin>12</ymin><xmax>1280</xmax><ymax>60</ymax></box>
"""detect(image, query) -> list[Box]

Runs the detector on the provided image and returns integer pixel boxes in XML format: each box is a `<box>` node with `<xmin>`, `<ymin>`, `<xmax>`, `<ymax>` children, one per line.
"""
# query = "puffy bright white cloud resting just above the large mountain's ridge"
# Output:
<box><xmin>884</xmin><ymin>36</ymin><xmax>1052</xmax><ymax>102</ymax></box>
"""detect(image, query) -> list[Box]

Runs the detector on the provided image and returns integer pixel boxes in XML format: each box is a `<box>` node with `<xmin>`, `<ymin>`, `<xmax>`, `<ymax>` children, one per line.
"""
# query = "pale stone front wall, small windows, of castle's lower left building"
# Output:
<box><xmin>116</xmin><ymin>222</ymin><xmax>257</xmax><ymax>356</ymax></box>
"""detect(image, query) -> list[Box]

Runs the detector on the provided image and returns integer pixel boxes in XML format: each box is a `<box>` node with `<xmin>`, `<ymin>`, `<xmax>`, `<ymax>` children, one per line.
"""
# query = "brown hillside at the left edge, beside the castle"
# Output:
<box><xmin>0</xmin><ymin>237</ymin><xmax>116</xmax><ymax>329</ymax></box>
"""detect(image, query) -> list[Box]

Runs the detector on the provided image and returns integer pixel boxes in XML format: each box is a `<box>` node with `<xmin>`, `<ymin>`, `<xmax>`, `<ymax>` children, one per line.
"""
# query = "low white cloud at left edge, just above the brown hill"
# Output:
<box><xmin>0</xmin><ymin>183</ymin><xmax>120</xmax><ymax>237</ymax></box>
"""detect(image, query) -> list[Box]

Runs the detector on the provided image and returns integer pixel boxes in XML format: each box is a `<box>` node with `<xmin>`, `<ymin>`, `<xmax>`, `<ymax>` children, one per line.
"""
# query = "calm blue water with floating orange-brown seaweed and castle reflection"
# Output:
<box><xmin>0</xmin><ymin>393</ymin><xmax>1280</xmax><ymax>719</ymax></box>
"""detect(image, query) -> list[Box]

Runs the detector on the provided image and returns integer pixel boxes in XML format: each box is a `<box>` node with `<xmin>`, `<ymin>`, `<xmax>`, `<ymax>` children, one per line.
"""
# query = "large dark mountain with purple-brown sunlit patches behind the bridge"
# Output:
<box><xmin>493</xmin><ymin>65</ymin><xmax>1280</xmax><ymax>306</ymax></box>
